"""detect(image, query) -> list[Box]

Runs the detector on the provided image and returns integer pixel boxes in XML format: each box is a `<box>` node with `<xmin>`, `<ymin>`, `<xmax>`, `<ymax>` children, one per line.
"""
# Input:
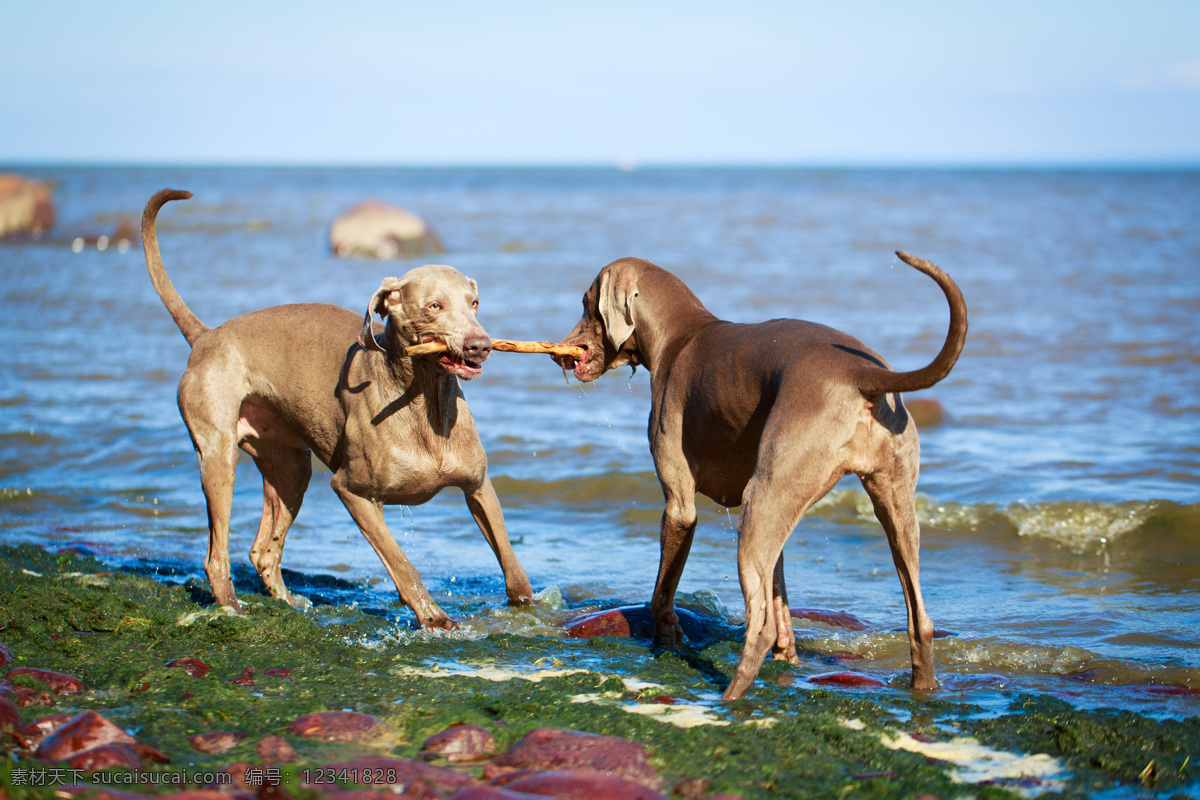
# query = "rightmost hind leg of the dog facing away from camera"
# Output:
<box><xmin>863</xmin><ymin>440</ymin><xmax>937</xmax><ymax>691</ymax></box>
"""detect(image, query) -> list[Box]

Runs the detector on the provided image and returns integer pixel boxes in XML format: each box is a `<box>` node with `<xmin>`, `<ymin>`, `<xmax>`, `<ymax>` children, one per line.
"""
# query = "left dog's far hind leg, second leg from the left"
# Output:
<box><xmin>244</xmin><ymin>441</ymin><xmax>312</xmax><ymax>608</ymax></box>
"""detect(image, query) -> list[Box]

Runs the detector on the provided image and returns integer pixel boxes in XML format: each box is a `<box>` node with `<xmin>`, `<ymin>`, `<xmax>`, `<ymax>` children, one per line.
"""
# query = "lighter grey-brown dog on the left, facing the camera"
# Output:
<box><xmin>142</xmin><ymin>190</ymin><xmax>533</xmax><ymax>628</ymax></box>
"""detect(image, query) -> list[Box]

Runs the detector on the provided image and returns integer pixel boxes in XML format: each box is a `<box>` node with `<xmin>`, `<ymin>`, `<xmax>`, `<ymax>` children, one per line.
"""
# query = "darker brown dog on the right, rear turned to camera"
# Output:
<box><xmin>556</xmin><ymin>253</ymin><xmax>967</xmax><ymax>699</ymax></box>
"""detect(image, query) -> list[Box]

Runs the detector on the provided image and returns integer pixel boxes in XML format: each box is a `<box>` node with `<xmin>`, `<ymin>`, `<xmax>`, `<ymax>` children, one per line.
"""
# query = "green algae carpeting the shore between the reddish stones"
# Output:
<box><xmin>0</xmin><ymin>546</ymin><xmax>1200</xmax><ymax>799</ymax></box>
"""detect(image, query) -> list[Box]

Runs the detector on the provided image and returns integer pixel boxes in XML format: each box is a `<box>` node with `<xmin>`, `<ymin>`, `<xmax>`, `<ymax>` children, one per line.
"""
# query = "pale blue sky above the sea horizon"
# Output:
<box><xmin>0</xmin><ymin>0</ymin><xmax>1200</xmax><ymax>166</ymax></box>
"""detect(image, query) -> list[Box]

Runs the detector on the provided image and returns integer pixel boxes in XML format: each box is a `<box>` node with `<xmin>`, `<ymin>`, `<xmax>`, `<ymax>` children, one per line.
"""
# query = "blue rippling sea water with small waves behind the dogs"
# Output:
<box><xmin>0</xmin><ymin>167</ymin><xmax>1200</xmax><ymax>715</ymax></box>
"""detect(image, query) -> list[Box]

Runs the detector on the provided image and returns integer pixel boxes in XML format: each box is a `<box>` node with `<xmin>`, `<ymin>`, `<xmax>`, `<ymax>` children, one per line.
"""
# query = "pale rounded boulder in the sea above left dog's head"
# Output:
<box><xmin>329</xmin><ymin>200</ymin><xmax>445</xmax><ymax>258</ymax></box>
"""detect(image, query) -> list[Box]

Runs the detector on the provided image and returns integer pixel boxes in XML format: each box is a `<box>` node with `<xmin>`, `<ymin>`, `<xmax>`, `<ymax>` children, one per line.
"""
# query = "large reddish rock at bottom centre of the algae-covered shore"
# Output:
<box><xmin>484</xmin><ymin>728</ymin><xmax>664</xmax><ymax>790</ymax></box>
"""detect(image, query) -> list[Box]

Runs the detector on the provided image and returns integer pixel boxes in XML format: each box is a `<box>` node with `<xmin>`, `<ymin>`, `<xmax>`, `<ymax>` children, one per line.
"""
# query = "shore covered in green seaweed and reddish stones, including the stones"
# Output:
<box><xmin>0</xmin><ymin>546</ymin><xmax>1200</xmax><ymax>800</ymax></box>
